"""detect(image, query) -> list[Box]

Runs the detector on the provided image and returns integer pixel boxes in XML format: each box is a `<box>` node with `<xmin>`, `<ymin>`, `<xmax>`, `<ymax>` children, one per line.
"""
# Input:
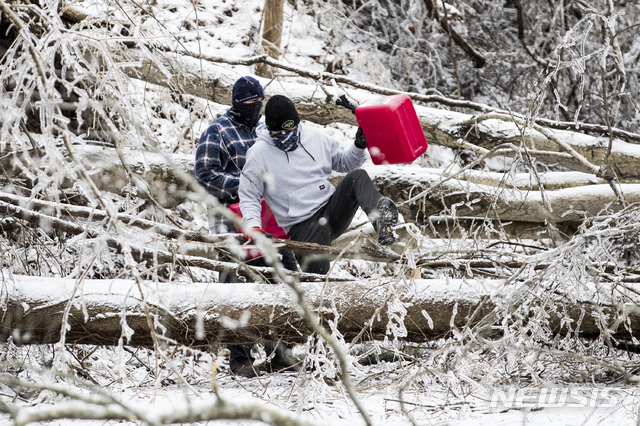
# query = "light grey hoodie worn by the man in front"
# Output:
<box><xmin>238</xmin><ymin>124</ymin><xmax>366</xmax><ymax>232</ymax></box>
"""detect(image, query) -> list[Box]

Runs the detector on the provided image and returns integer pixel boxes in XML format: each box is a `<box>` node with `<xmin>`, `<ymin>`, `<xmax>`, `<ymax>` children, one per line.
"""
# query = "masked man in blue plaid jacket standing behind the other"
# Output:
<box><xmin>194</xmin><ymin>77</ymin><xmax>299</xmax><ymax>377</ymax></box>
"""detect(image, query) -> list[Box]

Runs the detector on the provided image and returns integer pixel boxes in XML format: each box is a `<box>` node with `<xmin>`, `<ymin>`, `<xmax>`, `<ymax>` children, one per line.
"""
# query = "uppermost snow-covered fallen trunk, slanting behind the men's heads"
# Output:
<box><xmin>117</xmin><ymin>51</ymin><xmax>640</xmax><ymax>179</ymax></box>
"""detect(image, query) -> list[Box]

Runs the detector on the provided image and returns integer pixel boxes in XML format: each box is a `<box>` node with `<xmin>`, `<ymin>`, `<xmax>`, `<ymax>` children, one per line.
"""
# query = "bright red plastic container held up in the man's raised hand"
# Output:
<box><xmin>355</xmin><ymin>95</ymin><xmax>427</xmax><ymax>165</ymax></box>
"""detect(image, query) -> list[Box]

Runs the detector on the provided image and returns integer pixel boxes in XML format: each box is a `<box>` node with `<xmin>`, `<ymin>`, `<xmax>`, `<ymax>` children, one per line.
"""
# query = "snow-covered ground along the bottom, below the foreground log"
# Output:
<box><xmin>0</xmin><ymin>346</ymin><xmax>640</xmax><ymax>426</ymax></box>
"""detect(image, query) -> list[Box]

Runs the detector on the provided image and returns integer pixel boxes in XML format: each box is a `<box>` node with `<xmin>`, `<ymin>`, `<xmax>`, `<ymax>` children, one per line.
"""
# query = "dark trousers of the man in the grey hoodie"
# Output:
<box><xmin>289</xmin><ymin>169</ymin><xmax>382</xmax><ymax>274</ymax></box>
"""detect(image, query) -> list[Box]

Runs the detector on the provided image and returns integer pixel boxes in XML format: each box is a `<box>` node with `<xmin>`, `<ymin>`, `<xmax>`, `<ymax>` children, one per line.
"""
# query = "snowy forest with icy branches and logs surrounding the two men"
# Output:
<box><xmin>0</xmin><ymin>0</ymin><xmax>640</xmax><ymax>425</ymax></box>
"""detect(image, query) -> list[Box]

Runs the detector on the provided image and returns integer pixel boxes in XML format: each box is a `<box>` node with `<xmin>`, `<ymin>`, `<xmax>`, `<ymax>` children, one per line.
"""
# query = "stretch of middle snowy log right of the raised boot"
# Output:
<box><xmin>367</xmin><ymin>167</ymin><xmax>640</xmax><ymax>223</ymax></box>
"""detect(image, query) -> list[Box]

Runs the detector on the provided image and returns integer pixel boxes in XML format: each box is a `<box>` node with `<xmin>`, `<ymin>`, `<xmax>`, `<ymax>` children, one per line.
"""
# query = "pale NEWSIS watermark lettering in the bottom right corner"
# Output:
<box><xmin>490</xmin><ymin>387</ymin><xmax>622</xmax><ymax>408</ymax></box>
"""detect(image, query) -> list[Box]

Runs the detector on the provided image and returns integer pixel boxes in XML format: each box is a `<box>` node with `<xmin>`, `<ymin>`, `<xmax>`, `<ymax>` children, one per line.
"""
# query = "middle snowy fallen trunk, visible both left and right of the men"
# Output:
<box><xmin>6</xmin><ymin>146</ymin><xmax>640</xmax><ymax>235</ymax></box>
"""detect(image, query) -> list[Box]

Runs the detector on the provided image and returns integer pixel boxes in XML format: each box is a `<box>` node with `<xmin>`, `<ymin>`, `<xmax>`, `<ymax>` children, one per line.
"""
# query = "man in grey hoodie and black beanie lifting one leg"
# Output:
<box><xmin>238</xmin><ymin>95</ymin><xmax>398</xmax><ymax>274</ymax></box>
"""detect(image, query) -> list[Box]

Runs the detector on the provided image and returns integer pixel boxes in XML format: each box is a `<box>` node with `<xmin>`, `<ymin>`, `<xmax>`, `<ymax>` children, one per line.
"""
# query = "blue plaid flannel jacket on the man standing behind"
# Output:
<box><xmin>194</xmin><ymin>111</ymin><xmax>264</xmax><ymax>206</ymax></box>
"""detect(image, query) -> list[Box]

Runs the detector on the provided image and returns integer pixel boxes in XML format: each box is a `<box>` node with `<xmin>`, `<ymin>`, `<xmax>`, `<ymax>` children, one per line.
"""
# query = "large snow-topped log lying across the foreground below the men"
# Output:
<box><xmin>0</xmin><ymin>274</ymin><xmax>640</xmax><ymax>346</ymax></box>
